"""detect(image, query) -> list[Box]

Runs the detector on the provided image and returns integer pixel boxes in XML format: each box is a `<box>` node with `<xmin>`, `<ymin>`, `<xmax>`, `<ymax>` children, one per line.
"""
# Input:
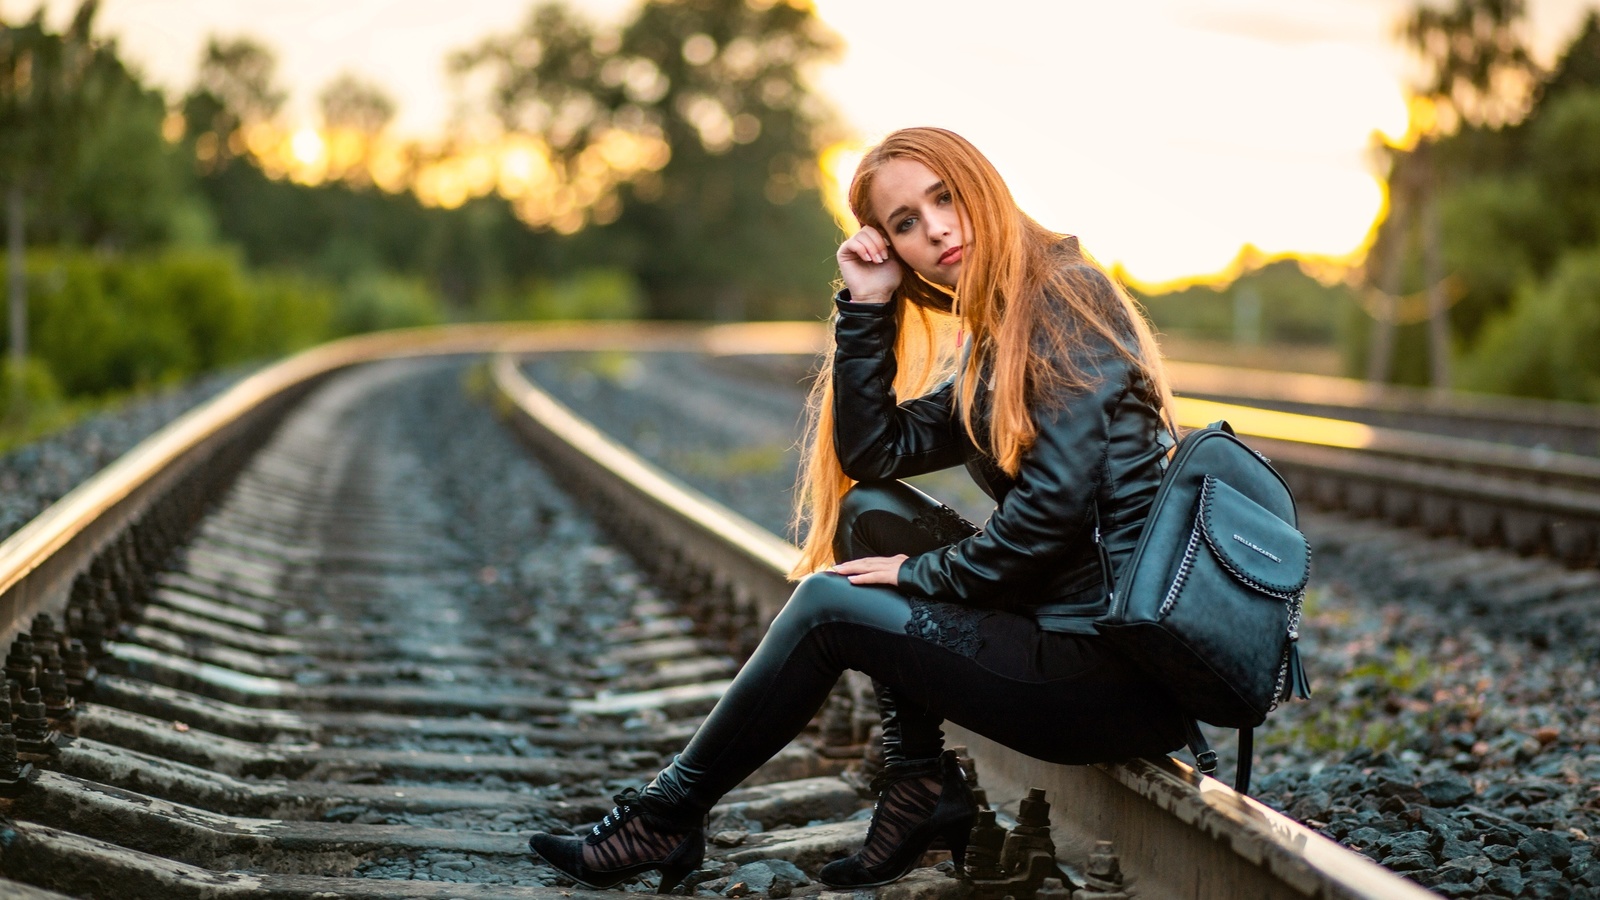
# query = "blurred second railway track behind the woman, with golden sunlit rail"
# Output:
<box><xmin>704</xmin><ymin>325</ymin><xmax>1600</xmax><ymax>569</ymax></box>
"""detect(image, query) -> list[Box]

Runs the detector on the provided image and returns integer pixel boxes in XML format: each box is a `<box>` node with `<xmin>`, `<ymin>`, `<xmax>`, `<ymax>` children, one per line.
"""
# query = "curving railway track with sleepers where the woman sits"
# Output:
<box><xmin>0</xmin><ymin>328</ymin><xmax>1561</xmax><ymax>898</ymax></box>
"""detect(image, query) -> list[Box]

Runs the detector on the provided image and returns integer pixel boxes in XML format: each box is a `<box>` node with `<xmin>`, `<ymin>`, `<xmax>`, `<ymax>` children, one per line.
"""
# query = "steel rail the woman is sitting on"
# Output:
<box><xmin>493</xmin><ymin>347</ymin><xmax>1434</xmax><ymax>900</ymax></box>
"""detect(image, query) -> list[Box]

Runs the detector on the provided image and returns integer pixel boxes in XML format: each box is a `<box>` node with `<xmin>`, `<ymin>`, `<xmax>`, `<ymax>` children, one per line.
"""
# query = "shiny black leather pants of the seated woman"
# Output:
<box><xmin>646</xmin><ymin>482</ymin><xmax>1184</xmax><ymax>815</ymax></box>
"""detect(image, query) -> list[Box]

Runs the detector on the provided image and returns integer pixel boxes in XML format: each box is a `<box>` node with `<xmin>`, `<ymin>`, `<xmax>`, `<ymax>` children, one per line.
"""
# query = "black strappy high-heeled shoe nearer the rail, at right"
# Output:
<box><xmin>819</xmin><ymin>749</ymin><xmax>978</xmax><ymax>887</ymax></box>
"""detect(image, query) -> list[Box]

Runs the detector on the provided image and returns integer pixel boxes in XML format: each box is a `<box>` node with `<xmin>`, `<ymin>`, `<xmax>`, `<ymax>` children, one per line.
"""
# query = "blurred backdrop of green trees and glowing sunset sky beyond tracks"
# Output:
<box><xmin>0</xmin><ymin>0</ymin><xmax>1600</xmax><ymax>442</ymax></box>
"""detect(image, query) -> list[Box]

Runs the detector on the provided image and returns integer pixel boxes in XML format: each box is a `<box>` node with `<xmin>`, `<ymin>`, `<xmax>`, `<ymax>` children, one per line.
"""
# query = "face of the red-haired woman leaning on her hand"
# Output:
<box><xmin>870</xmin><ymin>157</ymin><xmax>971</xmax><ymax>287</ymax></box>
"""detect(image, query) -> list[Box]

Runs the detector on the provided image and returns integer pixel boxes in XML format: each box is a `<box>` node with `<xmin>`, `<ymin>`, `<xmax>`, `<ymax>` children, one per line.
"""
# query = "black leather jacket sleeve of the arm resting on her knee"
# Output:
<box><xmin>899</xmin><ymin>339</ymin><xmax>1131</xmax><ymax>607</ymax></box>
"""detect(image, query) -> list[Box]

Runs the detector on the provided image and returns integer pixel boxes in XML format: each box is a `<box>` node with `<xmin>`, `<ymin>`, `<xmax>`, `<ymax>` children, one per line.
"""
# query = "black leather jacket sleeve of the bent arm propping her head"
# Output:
<box><xmin>834</xmin><ymin>291</ymin><xmax>968</xmax><ymax>480</ymax></box>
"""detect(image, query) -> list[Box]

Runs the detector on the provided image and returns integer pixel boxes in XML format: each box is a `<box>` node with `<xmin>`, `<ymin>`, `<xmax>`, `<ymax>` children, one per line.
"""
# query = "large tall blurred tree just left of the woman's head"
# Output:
<box><xmin>454</xmin><ymin>0</ymin><xmax>838</xmax><ymax>319</ymax></box>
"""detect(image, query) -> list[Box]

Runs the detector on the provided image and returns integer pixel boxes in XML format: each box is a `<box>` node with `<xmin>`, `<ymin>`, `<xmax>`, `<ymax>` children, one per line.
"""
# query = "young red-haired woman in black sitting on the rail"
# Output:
<box><xmin>530</xmin><ymin>128</ymin><xmax>1184</xmax><ymax>890</ymax></box>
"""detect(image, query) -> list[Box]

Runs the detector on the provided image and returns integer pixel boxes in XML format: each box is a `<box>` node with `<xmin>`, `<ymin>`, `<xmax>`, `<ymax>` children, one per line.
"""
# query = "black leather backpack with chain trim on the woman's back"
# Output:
<box><xmin>1094</xmin><ymin>421</ymin><xmax>1310</xmax><ymax>791</ymax></box>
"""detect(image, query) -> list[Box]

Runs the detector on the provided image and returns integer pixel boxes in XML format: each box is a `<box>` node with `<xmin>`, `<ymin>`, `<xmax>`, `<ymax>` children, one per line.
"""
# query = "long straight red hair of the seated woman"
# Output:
<box><xmin>789</xmin><ymin>128</ymin><xmax>1171</xmax><ymax>578</ymax></box>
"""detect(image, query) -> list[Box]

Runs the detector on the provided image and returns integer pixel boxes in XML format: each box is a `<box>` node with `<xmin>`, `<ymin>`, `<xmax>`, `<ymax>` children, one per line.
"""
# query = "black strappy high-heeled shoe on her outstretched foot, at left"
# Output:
<box><xmin>528</xmin><ymin>788</ymin><xmax>706</xmax><ymax>894</ymax></box>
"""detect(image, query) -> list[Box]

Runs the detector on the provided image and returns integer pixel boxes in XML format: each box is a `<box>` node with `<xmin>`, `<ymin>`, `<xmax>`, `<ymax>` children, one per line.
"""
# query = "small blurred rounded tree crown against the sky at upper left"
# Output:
<box><xmin>182</xmin><ymin>37</ymin><xmax>288</xmax><ymax>171</ymax></box>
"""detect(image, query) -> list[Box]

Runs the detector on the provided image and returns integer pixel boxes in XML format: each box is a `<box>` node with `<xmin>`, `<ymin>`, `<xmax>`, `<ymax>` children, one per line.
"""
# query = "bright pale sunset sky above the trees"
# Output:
<box><xmin>9</xmin><ymin>0</ymin><xmax>1590</xmax><ymax>282</ymax></box>
